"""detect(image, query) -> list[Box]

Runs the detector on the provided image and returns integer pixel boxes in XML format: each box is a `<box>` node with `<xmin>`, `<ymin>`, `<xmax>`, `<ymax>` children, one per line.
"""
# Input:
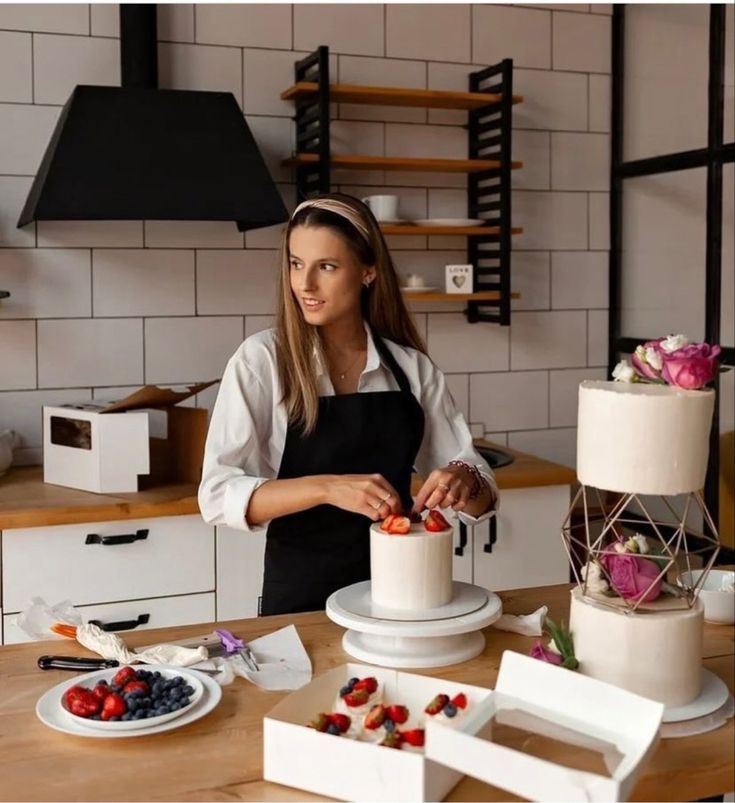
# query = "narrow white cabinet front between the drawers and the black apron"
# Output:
<box><xmin>217</xmin><ymin>526</ymin><xmax>265</xmax><ymax>622</ymax></box>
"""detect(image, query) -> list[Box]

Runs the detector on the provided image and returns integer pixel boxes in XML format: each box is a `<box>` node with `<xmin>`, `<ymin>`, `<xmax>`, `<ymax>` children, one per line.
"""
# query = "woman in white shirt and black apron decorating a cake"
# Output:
<box><xmin>199</xmin><ymin>194</ymin><xmax>496</xmax><ymax>614</ymax></box>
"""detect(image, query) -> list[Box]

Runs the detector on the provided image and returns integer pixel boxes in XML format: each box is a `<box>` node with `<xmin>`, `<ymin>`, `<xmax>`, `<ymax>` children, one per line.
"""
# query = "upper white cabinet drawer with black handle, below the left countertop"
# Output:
<box><xmin>2</xmin><ymin>516</ymin><xmax>215</xmax><ymax>613</ymax></box>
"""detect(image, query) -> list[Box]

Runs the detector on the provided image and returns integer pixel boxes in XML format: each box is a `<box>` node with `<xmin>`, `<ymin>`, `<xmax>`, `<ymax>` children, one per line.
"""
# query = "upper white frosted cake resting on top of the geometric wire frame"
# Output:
<box><xmin>577</xmin><ymin>381</ymin><xmax>715</xmax><ymax>495</ymax></box>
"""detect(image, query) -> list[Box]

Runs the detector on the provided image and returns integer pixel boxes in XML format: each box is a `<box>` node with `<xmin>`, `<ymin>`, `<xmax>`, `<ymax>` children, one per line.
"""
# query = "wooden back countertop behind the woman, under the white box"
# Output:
<box><xmin>0</xmin><ymin>440</ymin><xmax>576</xmax><ymax>530</ymax></box>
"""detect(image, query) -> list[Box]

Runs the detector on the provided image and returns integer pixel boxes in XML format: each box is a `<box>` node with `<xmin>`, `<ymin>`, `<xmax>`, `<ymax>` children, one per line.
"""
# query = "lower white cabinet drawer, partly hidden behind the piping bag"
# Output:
<box><xmin>3</xmin><ymin>592</ymin><xmax>215</xmax><ymax>653</ymax></box>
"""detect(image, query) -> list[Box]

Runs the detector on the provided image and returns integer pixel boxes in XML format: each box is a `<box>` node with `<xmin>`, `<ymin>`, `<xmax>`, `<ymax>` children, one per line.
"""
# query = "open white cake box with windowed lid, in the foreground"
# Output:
<box><xmin>263</xmin><ymin>651</ymin><xmax>664</xmax><ymax>801</ymax></box>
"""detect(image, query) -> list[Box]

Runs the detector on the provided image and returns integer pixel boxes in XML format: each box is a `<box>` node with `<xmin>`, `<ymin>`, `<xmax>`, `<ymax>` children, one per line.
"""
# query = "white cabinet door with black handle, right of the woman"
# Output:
<box><xmin>474</xmin><ymin>485</ymin><xmax>570</xmax><ymax>591</ymax></box>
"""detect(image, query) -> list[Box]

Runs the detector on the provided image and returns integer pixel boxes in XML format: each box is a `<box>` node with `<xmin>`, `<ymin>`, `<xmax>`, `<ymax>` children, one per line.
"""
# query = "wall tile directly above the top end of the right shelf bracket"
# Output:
<box><xmin>472</xmin><ymin>4</ymin><xmax>551</xmax><ymax>70</ymax></box>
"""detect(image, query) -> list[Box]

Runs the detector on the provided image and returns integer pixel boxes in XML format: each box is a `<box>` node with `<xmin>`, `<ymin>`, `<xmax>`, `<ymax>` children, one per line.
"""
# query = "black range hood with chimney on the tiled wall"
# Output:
<box><xmin>18</xmin><ymin>3</ymin><xmax>288</xmax><ymax>231</ymax></box>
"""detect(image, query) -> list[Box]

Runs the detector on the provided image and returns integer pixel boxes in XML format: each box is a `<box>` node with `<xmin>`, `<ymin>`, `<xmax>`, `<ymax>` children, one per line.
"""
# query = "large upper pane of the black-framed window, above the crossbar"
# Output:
<box><xmin>623</xmin><ymin>3</ymin><xmax>709</xmax><ymax>161</ymax></box>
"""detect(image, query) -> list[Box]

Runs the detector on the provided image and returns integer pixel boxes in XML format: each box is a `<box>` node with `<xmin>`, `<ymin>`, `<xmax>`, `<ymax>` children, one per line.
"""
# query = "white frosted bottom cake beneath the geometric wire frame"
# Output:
<box><xmin>569</xmin><ymin>588</ymin><xmax>704</xmax><ymax>707</ymax></box>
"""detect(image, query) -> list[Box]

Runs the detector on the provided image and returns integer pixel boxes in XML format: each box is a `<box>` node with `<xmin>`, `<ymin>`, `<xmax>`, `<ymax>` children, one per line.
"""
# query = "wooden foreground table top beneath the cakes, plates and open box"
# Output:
<box><xmin>0</xmin><ymin>585</ymin><xmax>735</xmax><ymax>801</ymax></box>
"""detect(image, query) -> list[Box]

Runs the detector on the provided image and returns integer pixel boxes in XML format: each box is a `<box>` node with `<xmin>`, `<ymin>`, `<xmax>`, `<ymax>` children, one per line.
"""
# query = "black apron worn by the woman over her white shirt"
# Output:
<box><xmin>260</xmin><ymin>336</ymin><xmax>424</xmax><ymax>616</ymax></box>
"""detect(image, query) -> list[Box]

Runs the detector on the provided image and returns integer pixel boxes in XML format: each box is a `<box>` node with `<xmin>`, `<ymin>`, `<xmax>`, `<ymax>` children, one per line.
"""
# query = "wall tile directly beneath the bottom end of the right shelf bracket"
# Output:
<box><xmin>428</xmin><ymin>313</ymin><xmax>508</xmax><ymax>373</ymax></box>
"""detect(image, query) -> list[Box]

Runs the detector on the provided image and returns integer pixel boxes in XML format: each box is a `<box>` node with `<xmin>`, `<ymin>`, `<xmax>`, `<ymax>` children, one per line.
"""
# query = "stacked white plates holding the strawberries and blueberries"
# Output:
<box><xmin>36</xmin><ymin>666</ymin><xmax>222</xmax><ymax>739</ymax></box>
